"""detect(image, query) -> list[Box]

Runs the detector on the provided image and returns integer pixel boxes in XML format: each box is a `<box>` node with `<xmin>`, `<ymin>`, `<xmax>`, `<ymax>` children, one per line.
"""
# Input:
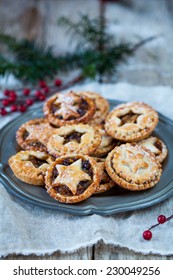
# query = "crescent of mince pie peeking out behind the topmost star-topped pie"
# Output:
<box><xmin>79</xmin><ymin>91</ymin><xmax>110</xmax><ymax>125</ymax></box>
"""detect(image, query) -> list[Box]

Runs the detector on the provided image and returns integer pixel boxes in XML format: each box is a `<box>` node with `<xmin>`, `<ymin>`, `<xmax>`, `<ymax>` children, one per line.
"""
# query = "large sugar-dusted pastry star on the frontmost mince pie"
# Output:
<box><xmin>52</xmin><ymin>159</ymin><xmax>91</xmax><ymax>195</ymax></box>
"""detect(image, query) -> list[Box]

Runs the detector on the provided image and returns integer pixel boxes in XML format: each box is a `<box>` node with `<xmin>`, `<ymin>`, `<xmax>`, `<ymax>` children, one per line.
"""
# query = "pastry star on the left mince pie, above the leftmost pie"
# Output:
<box><xmin>26</xmin><ymin>123</ymin><xmax>55</xmax><ymax>145</ymax></box>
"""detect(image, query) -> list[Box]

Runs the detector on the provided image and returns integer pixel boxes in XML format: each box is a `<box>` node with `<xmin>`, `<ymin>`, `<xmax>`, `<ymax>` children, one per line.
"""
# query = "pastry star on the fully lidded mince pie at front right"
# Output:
<box><xmin>122</xmin><ymin>151</ymin><xmax>148</xmax><ymax>173</ymax></box>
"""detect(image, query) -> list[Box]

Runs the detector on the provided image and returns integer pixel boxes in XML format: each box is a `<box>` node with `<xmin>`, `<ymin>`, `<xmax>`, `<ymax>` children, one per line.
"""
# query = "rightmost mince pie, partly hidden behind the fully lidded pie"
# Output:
<box><xmin>137</xmin><ymin>136</ymin><xmax>168</xmax><ymax>162</ymax></box>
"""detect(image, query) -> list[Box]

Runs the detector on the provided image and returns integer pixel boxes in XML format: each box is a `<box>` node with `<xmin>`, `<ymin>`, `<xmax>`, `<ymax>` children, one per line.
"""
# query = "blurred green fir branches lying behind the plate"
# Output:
<box><xmin>0</xmin><ymin>15</ymin><xmax>156</xmax><ymax>84</ymax></box>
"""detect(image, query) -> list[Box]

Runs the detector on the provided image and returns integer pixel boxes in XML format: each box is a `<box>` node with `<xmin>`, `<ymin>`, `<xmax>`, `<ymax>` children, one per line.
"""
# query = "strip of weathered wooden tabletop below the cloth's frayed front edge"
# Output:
<box><xmin>0</xmin><ymin>242</ymin><xmax>173</xmax><ymax>260</ymax></box>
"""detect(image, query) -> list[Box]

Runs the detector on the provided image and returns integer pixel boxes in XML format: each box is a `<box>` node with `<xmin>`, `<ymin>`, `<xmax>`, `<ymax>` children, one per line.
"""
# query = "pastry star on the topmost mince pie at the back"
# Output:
<box><xmin>54</xmin><ymin>103</ymin><xmax>80</xmax><ymax>120</ymax></box>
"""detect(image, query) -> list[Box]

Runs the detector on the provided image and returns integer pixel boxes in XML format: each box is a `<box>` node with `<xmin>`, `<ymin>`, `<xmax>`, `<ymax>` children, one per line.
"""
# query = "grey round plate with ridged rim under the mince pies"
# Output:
<box><xmin>0</xmin><ymin>100</ymin><xmax>173</xmax><ymax>215</ymax></box>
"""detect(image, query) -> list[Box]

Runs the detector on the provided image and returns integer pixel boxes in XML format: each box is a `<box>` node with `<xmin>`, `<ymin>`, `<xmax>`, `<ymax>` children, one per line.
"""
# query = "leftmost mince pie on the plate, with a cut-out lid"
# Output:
<box><xmin>8</xmin><ymin>151</ymin><xmax>54</xmax><ymax>186</ymax></box>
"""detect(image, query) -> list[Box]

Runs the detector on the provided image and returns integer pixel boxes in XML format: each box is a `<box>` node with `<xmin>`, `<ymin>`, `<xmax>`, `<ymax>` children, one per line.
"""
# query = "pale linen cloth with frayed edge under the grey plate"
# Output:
<box><xmin>0</xmin><ymin>83</ymin><xmax>173</xmax><ymax>256</ymax></box>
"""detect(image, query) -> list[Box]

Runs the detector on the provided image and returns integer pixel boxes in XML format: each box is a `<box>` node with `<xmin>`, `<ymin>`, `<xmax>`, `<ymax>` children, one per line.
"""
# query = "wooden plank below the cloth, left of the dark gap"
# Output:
<box><xmin>0</xmin><ymin>247</ymin><xmax>93</xmax><ymax>260</ymax></box>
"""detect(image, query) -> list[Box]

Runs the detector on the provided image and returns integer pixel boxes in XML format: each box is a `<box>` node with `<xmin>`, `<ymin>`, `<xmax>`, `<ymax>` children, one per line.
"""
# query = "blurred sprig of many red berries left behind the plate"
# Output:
<box><xmin>0</xmin><ymin>76</ymin><xmax>83</xmax><ymax>117</ymax></box>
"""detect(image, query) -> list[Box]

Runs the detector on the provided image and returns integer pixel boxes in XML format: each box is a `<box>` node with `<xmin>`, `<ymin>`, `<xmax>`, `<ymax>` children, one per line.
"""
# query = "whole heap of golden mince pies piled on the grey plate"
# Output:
<box><xmin>9</xmin><ymin>91</ymin><xmax>168</xmax><ymax>203</ymax></box>
